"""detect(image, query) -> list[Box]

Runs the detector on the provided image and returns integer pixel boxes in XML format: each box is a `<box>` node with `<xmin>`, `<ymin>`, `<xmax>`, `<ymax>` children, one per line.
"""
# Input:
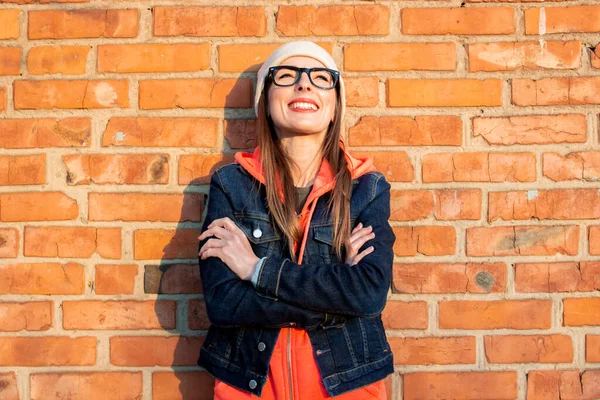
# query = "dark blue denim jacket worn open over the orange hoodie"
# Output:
<box><xmin>198</xmin><ymin>154</ymin><xmax>395</xmax><ymax>397</ymax></box>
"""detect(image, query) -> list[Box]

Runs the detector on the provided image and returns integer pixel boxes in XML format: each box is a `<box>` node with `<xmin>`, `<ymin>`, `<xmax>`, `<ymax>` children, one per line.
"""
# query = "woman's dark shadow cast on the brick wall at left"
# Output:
<box><xmin>151</xmin><ymin>69</ymin><xmax>256</xmax><ymax>400</ymax></box>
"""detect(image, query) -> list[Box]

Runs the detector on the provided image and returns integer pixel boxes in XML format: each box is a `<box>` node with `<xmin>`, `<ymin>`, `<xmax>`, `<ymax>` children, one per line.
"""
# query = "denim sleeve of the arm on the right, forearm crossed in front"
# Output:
<box><xmin>256</xmin><ymin>175</ymin><xmax>395</xmax><ymax>317</ymax></box>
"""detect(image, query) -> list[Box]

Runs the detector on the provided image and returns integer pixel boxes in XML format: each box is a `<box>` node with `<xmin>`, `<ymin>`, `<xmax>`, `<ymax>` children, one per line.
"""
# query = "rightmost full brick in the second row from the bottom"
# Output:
<box><xmin>484</xmin><ymin>335</ymin><xmax>573</xmax><ymax>364</ymax></box>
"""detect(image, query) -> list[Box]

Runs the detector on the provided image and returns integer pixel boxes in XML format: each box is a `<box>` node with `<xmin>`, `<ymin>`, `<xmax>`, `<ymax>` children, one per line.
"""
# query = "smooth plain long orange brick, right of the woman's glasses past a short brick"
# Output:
<box><xmin>387</xmin><ymin>78</ymin><xmax>502</xmax><ymax>107</ymax></box>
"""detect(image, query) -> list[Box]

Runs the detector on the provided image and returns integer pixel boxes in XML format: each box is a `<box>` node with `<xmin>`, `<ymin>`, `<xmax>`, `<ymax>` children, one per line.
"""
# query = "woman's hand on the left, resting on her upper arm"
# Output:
<box><xmin>198</xmin><ymin>217</ymin><xmax>259</xmax><ymax>280</ymax></box>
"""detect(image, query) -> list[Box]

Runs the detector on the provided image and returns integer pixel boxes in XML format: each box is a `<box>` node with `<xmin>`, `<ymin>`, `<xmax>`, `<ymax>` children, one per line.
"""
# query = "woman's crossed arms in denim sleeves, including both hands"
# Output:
<box><xmin>199</xmin><ymin>172</ymin><xmax>395</xmax><ymax>329</ymax></box>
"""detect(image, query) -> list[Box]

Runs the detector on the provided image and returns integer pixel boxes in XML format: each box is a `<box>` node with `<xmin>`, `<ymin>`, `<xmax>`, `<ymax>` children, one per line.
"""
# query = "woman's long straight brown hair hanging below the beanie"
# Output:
<box><xmin>257</xmin><ymin>77</ymin><xmax>352</xmax><ymax>262</ymax></box>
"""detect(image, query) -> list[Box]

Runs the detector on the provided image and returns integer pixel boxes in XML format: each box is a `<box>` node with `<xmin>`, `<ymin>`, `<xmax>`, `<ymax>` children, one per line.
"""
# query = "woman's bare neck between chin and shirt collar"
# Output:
<box><xmin>281</xmin><ymin>133</ymin><xmax>325</xmax><ymax>187</ymax></box>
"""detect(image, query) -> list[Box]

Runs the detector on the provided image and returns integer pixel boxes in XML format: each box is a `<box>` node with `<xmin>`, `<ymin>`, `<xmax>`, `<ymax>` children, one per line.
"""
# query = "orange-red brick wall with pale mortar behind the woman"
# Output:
<box><xmin>0</xmin><ymin>0</ymin><xmax>600</xmax><ymax>400</ymax></box>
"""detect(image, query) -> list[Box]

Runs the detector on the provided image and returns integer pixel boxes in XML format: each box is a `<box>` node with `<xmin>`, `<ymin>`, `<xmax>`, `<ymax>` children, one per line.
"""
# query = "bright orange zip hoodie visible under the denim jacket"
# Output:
<box><xmin>214</xmin><ymin>142</ymin><xmax>386</xmax><ymax>400</ymax></box>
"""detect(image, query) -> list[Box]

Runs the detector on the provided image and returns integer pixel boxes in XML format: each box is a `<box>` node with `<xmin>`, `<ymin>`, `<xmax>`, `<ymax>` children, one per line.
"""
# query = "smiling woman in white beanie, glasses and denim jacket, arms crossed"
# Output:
<box><xmin>198</xmin><ymin>42</ymin><xmax>395</xmax><ymax>400</ymax></box>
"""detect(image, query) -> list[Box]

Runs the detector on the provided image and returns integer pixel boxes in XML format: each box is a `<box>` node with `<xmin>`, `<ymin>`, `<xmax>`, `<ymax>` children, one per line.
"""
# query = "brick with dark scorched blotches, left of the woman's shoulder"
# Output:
<box><xmin>62</xmin><ymin>154</ymin><xmax>169</xmax><ymax>185</ymax></box>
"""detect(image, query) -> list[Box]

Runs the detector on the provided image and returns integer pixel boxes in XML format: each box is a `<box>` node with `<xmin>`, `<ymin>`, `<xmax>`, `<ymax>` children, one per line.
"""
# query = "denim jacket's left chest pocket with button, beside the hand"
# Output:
<box><xmin>235</xmin><ymin>214</ymin><xmax>281</xmax><ymax>258</ymax></box>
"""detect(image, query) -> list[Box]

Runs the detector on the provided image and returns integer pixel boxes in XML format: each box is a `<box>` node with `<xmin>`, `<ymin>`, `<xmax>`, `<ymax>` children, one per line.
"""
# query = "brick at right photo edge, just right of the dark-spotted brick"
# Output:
<box><xmin>515</xmin><ymin>261</ymin><xmax>600</xmax><ymax>293</ymax></box>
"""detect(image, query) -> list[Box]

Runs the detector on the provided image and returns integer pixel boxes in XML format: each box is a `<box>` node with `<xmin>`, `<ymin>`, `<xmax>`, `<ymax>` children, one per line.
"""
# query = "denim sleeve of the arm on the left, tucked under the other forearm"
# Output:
<box><xmin>198</xmin><ymin>171</ymin><xmax>326</xmax><ymax>329</ymax></box>
